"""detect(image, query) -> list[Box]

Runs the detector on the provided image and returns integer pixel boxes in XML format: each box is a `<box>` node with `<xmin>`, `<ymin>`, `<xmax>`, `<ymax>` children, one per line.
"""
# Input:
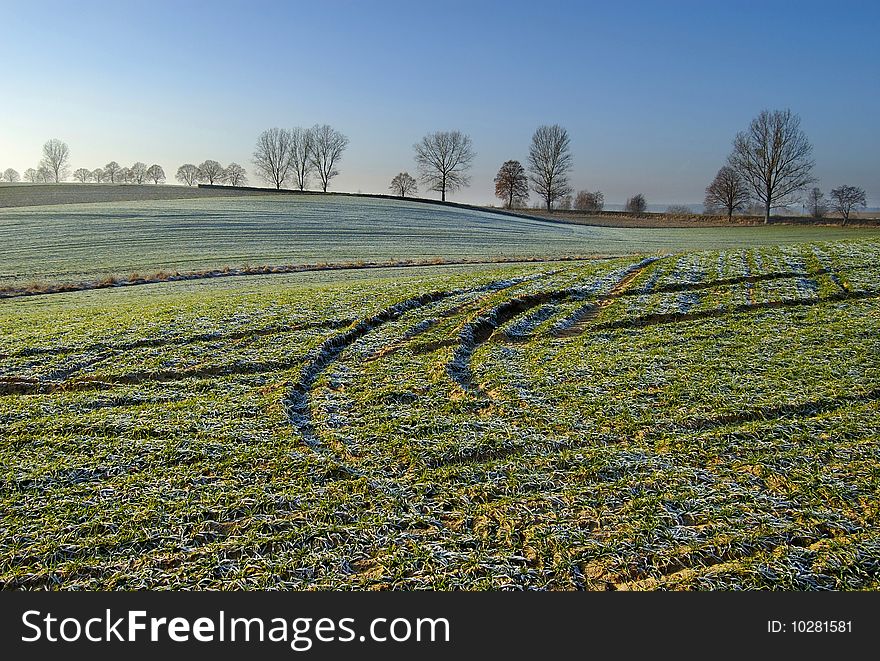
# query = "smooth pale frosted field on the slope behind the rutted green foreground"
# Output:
<box><xmin>0</xmin><ymin>196</ymin><xmax>880</xmax><ymax>288</ymax></box>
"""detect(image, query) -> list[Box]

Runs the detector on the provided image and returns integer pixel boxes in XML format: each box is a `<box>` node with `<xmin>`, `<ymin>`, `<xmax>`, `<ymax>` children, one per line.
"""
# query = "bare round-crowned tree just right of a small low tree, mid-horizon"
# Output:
<box><xmin>413</xmin><ymin>131</ymin><xmax>475</xmax><ymax>202</ymax></box>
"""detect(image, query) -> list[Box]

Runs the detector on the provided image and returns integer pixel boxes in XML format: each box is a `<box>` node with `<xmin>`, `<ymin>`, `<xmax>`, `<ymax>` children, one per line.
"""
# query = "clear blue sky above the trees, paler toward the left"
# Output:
<box><xmin>0</xmin><ymin>0</ymin><xmax>880</xmax><ymax>206</ymax></box>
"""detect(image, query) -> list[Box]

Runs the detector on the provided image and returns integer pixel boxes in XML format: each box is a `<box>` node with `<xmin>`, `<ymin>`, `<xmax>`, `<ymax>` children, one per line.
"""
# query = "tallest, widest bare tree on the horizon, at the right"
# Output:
<box><xmin>728</xmin><ymin>109</ymin><xmax>815</xmax><ymax>223</ymax></box>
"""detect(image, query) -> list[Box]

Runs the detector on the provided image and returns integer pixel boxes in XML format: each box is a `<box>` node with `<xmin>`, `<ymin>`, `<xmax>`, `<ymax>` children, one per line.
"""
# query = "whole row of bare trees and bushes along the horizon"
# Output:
<box><xmin>2</xmin><ymin>109</ymin><xmax>866</xmax><ymax>223</ymax></box>
